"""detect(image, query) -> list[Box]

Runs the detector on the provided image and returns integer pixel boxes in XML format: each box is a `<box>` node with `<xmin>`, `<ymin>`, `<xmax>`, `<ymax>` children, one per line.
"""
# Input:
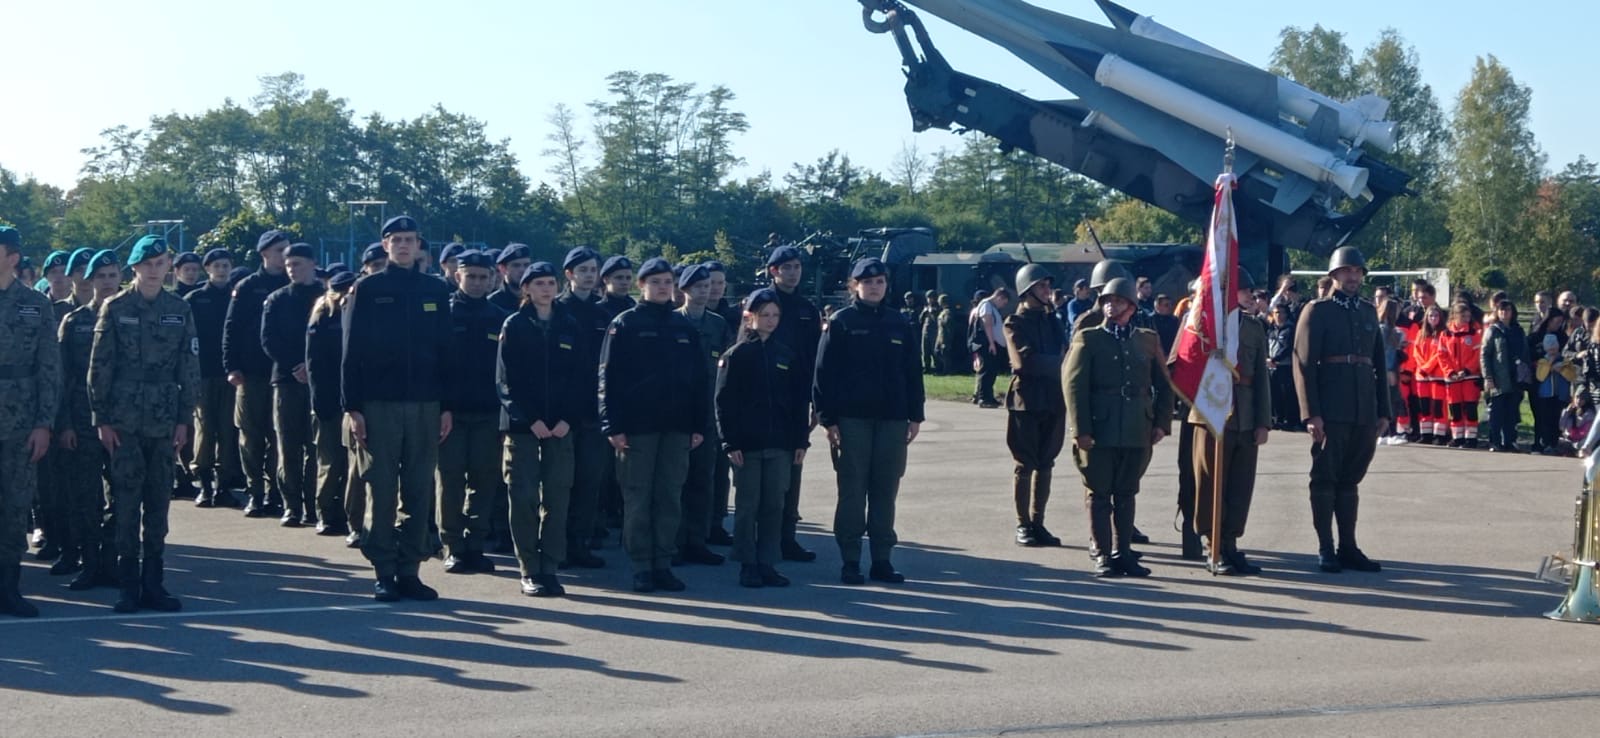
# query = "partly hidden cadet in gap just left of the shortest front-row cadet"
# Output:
<box><xmin>678</xmin><ymin>264</ymin><xmax>734</xmax><ymax>567</ymax></box>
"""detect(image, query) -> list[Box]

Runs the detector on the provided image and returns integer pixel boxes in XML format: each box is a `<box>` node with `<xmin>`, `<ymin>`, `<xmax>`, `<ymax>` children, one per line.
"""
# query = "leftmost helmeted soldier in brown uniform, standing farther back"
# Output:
<box><xmin>1005</xmin><ymin>264</ymin><xmax>1067</xmax><ymax>546</ymax></box>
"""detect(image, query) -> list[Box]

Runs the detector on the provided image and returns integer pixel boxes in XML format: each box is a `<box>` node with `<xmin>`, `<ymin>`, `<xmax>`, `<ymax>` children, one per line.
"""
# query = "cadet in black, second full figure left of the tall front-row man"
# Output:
<box><xmin>261</xmin><ymin>243</ymin><xmax>326</xmax><ymax>528</ymax></box>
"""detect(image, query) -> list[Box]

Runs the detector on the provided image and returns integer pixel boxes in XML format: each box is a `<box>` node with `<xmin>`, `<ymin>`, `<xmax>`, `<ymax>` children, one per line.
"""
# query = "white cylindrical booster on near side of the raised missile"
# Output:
<box><xmin>1059</xmin><ymin>46</ymin><xmax>1368</xmax><ymax>197</ymax></box>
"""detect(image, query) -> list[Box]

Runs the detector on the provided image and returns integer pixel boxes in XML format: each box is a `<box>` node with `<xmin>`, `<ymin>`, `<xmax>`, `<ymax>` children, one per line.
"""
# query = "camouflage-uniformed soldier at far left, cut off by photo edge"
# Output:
<box><xmin>0</xmin><ymin>226</ymin><xmax>61</xmax><ymax>618</ymax></box>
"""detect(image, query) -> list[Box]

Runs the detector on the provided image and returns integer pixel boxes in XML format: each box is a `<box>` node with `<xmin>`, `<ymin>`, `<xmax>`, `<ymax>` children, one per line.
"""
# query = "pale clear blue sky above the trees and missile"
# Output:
<box><xmin>0</xmin><ymin>0</ymin><xmax>1600</xmax><ymax>195</ymax></box>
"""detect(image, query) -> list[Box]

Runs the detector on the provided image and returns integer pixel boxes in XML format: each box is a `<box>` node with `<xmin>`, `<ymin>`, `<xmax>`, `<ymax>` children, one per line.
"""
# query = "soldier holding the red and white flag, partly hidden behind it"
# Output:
<box><xmin>1179</xmin><ymin>269</ymin><xmax>1272</xmax><ymax>575</ymax></box>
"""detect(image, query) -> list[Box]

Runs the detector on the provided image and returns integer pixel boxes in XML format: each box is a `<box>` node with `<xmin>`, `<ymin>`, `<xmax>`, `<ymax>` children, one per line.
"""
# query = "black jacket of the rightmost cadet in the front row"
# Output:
<box><xmin>812</xmin><ymin>301</ymin><xmax>923</xmax><ymax>426</ymax></box>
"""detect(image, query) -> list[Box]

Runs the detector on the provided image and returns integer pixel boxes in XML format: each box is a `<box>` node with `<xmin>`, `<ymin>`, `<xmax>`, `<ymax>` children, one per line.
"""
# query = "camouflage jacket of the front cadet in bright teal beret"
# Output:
<box><xmin>90</xmin><ymin>287</ymin><xmax>200</xmax><ymax>439</ymax></box>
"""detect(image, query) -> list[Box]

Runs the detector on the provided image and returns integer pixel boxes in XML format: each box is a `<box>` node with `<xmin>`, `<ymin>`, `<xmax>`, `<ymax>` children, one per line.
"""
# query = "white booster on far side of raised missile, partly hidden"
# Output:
<box><xmin>1094</xmin><ymin>0</ymin><xmax>1397</xmax><ymax>154</ymax></box>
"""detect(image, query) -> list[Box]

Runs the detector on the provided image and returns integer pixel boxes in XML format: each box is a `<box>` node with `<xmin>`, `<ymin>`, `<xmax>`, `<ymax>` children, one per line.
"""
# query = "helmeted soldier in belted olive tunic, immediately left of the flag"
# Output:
<box><xmin>1062</xmin><ymin>277</ymin><xmax>1173</xmax><ymax>576</ymax></box>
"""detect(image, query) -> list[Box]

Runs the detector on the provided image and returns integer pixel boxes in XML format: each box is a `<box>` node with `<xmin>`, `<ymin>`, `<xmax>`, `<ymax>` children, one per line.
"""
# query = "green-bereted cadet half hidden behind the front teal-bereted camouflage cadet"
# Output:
<box><xmin>56</xmin><ymin>250</ymin><xmax>122</xmax><ymax>589</ymax></box>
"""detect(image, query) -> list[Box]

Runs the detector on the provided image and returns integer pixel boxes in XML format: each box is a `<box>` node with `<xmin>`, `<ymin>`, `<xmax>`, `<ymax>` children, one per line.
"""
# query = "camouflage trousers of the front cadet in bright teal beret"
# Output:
<box><xmin>110</xmin><ymin>431</ymin><xmax>176</xmax><ymax>562</ymax></box>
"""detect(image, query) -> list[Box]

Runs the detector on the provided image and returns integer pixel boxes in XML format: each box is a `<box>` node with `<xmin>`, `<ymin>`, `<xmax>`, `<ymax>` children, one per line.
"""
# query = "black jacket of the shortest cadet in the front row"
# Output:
<box><xmin>717</xmin><ymin>338</ymin><xmax>811</xmax><ymax>451</ymax></box>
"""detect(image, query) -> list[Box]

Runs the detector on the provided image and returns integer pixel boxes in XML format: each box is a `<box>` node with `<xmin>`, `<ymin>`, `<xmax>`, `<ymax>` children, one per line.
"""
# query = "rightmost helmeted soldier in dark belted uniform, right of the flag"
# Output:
<box><xmin>1294</xmin><ymin>247</ymin><xmax>1390</xmax><ymax>573</ymax></box>
